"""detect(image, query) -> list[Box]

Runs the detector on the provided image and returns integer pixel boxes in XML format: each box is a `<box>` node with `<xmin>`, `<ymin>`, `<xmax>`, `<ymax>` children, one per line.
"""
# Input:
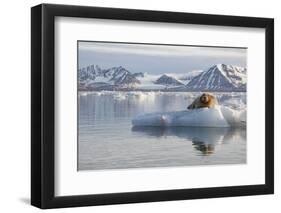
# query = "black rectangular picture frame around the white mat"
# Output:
<box><xmin>31</xmin><ymin>4</ymin><xmax>274</xmax><ymax>209</ymax></box>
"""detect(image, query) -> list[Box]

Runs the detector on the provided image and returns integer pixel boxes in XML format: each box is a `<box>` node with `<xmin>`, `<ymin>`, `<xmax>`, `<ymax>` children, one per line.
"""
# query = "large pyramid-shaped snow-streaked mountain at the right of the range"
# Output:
<box><xmin>186</xmin><ymin>64</ymin><xmax>247</xmax><ymax>92</ymax></box>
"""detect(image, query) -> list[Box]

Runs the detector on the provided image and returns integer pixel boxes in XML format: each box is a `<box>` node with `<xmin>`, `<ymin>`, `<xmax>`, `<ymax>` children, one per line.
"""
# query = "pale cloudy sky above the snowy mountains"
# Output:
<box><xmin>78</xmin><ymin>41</ymin><xmax>247</xmax><ymax>74</ymax></box>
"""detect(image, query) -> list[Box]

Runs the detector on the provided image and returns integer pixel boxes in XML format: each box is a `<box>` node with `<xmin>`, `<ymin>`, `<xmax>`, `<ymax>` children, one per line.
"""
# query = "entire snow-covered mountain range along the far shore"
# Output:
<box><xmin>78</xmin><ymin>64</ymin><xmax>247</xmax><ymax>92</ymax></box>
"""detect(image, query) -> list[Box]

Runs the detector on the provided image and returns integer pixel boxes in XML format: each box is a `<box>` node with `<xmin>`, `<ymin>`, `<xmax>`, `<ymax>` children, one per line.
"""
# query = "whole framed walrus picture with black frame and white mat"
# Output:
<box><xmin>31</xmin><ymin>4</ymin><xmax>274</xmax><ymax>208</ymax></box>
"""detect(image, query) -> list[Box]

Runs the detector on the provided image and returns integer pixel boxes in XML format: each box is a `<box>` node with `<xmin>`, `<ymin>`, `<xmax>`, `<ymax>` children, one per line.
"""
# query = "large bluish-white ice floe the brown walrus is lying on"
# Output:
<box><xmin>132</xmin><ymin>106</ymin><xmax>246</xmax><ymax>127</ymax></box>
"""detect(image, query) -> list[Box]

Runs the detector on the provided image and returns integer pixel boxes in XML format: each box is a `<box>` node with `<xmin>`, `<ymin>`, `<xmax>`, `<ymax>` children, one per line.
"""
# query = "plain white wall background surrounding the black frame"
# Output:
<box><xmin>0</xmin><ymin>0</ymin><xmax>276</xmax><ymax>213</ymax></box>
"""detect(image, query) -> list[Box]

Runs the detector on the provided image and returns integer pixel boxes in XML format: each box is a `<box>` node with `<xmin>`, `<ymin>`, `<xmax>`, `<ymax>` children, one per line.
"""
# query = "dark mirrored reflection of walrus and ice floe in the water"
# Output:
<box><xmin>132</xmin><ymin>127</ymin><xmax>246</xmax><ymax>155</ymax></box>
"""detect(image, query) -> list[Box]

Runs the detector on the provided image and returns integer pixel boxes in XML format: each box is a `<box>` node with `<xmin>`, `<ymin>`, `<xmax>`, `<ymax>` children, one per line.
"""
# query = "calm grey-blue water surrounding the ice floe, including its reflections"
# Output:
<box><xmin>78</xmin><ymin>92</ymin><xmax>246</xmax><ymax>170</ymax></box>
